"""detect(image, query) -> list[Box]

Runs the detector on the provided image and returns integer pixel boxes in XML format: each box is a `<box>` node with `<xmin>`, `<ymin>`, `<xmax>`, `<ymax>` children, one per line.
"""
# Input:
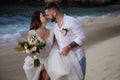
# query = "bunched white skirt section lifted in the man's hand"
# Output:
<box><xmin>47</xmin><ymin>46</ymin><xmax>83</xmax><ymax>80</ymax></box>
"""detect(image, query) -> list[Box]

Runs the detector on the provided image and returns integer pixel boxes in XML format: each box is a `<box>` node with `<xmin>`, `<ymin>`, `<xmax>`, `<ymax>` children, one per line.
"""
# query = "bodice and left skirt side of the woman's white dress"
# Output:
<box><xmin>23</xmin><ymin>30</ymin><xmax>54</xmax><ymax>80</ymax></box>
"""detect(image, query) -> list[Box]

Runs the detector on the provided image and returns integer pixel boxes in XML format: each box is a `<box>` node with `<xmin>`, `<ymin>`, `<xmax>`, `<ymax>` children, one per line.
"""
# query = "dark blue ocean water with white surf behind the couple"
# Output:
<box><xmin>0</xmin><ymin>5</ymin><xmax>120</xmax><ymax>45</ymax></box>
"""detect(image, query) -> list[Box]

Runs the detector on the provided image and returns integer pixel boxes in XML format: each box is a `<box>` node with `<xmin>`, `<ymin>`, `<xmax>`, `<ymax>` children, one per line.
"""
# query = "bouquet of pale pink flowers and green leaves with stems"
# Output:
<box><xmin>15</xmin><ymin>34</ymin><xmax>46</xmax><ymax>67</ymax></box>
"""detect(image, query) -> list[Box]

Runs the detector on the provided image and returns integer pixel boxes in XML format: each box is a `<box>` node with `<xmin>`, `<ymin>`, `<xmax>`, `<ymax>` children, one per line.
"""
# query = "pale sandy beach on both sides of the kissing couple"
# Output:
<box><xmin>0</xmin><ymin>16</ymin><xmax>120</xmax><ymax>80</ymax></box>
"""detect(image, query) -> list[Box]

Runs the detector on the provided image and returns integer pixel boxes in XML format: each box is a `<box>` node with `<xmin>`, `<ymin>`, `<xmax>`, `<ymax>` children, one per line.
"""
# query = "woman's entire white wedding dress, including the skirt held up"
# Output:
<box><xmin>23</xmin><ymin>30</ymin><xmax>83</xmax><ymax>80</ymax></box>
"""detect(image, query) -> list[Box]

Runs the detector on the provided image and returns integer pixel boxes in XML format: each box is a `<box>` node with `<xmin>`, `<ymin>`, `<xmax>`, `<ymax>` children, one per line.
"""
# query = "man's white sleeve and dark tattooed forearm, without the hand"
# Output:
<box><xmin>69</xmin><ymin>19</ymin><xmax>85</xmax><ymax>48</ymax></box>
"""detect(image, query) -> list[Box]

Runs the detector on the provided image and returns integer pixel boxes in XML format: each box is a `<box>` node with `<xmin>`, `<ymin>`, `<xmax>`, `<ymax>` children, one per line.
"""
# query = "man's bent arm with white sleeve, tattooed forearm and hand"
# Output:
<box><xmin>62</xmin><ymin>19</ymin><xmax>85</xmax><ymax>55</ymax></box>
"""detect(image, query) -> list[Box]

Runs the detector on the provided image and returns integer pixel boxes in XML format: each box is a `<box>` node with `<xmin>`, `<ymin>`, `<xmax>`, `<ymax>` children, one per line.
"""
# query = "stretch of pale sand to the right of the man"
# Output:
<box><xmin>84</xmin><ymin>17</ymin><xmax>120</xmax><ymax>80</ymax></box>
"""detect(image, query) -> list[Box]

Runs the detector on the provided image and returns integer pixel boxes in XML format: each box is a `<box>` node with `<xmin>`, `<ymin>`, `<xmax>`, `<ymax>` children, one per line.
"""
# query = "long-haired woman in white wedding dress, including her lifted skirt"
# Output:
<box><xmin>23</xmin><ymin>11</ymin><xmax>83</xmax><ymax>80</ymax></box>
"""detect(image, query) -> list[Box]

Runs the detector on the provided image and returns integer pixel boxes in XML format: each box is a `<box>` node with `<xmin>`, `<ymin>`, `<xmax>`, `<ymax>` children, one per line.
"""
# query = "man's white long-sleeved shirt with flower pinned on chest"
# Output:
<box><xmin>53</xmin><ymin>15</ymin><xmax>85</xmax><ymax>60</ymax></box>
